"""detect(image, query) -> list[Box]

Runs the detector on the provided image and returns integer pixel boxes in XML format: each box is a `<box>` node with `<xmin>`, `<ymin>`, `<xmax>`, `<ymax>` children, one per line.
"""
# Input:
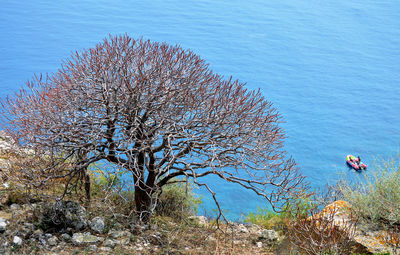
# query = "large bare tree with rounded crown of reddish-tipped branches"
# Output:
<box><xmin>1</xmin><ymin>35</ymin><xmax>303</xmax><ymax>222</ymax></box>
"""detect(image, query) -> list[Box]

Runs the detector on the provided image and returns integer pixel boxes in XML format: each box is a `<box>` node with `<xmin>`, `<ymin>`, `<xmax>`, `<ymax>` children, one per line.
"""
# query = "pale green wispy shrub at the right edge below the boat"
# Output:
<box><xmin>340</xmin><ymin>157</ymin><xmax>400</xmax><ymax>224</ymax></box>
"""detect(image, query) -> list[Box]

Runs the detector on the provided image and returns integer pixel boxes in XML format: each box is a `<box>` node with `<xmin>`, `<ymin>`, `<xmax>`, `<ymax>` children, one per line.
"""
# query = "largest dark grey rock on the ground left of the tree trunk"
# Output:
<box><xmin>41</xmin><ymin>200</ymin><xmax>87</xmax><ymax>230</ymax></box>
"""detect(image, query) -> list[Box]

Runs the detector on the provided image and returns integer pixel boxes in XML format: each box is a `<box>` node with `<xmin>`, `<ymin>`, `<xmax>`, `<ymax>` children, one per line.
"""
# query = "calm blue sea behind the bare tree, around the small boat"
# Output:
<box><xmin>0</xmin><ymin>0</ymin><xmax>400</xmax><ymax>219</ymax></box>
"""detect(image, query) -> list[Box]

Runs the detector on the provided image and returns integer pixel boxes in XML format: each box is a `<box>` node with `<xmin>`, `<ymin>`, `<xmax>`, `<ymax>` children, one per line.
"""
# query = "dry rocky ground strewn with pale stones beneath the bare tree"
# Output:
<box><xmin>0</xmin><ymin>199</ymin><xmax>279</xmax><ymax>254</ymax></box>
